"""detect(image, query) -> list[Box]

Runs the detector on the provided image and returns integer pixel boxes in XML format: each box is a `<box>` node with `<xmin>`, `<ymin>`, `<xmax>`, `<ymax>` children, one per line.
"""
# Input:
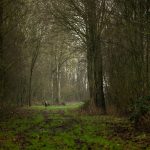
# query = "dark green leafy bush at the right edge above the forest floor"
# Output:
<box><xmin>130</xmin><ymin>96</ymin><xmax>150</xmax><ymax>124</ymax></box>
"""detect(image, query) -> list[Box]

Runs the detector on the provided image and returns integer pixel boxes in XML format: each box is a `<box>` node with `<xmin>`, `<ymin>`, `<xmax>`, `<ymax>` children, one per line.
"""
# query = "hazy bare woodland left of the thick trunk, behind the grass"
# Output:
<box><xmin>0</xmin><ymin>0</ymin><xmax>88</xmax><ymax>108</ymax></box>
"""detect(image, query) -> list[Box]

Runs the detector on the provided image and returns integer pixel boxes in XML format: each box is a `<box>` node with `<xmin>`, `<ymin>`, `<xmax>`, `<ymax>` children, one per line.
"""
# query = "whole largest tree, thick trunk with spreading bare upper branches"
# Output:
<box><xmin>52</xmin><ymin>0</ymin><xmax>112</xmax><ymax>113</ymax></box>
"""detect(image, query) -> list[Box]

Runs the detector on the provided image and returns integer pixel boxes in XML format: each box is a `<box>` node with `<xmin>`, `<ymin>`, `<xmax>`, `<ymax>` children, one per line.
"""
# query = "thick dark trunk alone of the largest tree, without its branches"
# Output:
<box><xmin>87</xmin><ymin>0</ymin><xmax>106</xmax><ymax>113</ymax></box>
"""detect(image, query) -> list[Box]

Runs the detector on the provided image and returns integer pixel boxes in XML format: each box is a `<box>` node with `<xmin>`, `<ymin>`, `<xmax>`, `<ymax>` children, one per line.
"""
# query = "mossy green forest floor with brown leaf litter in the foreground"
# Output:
<box><xmin>0</xmin><ymin>106</ymin><xmax>150</xmax><ymax>150</ymax></box>
